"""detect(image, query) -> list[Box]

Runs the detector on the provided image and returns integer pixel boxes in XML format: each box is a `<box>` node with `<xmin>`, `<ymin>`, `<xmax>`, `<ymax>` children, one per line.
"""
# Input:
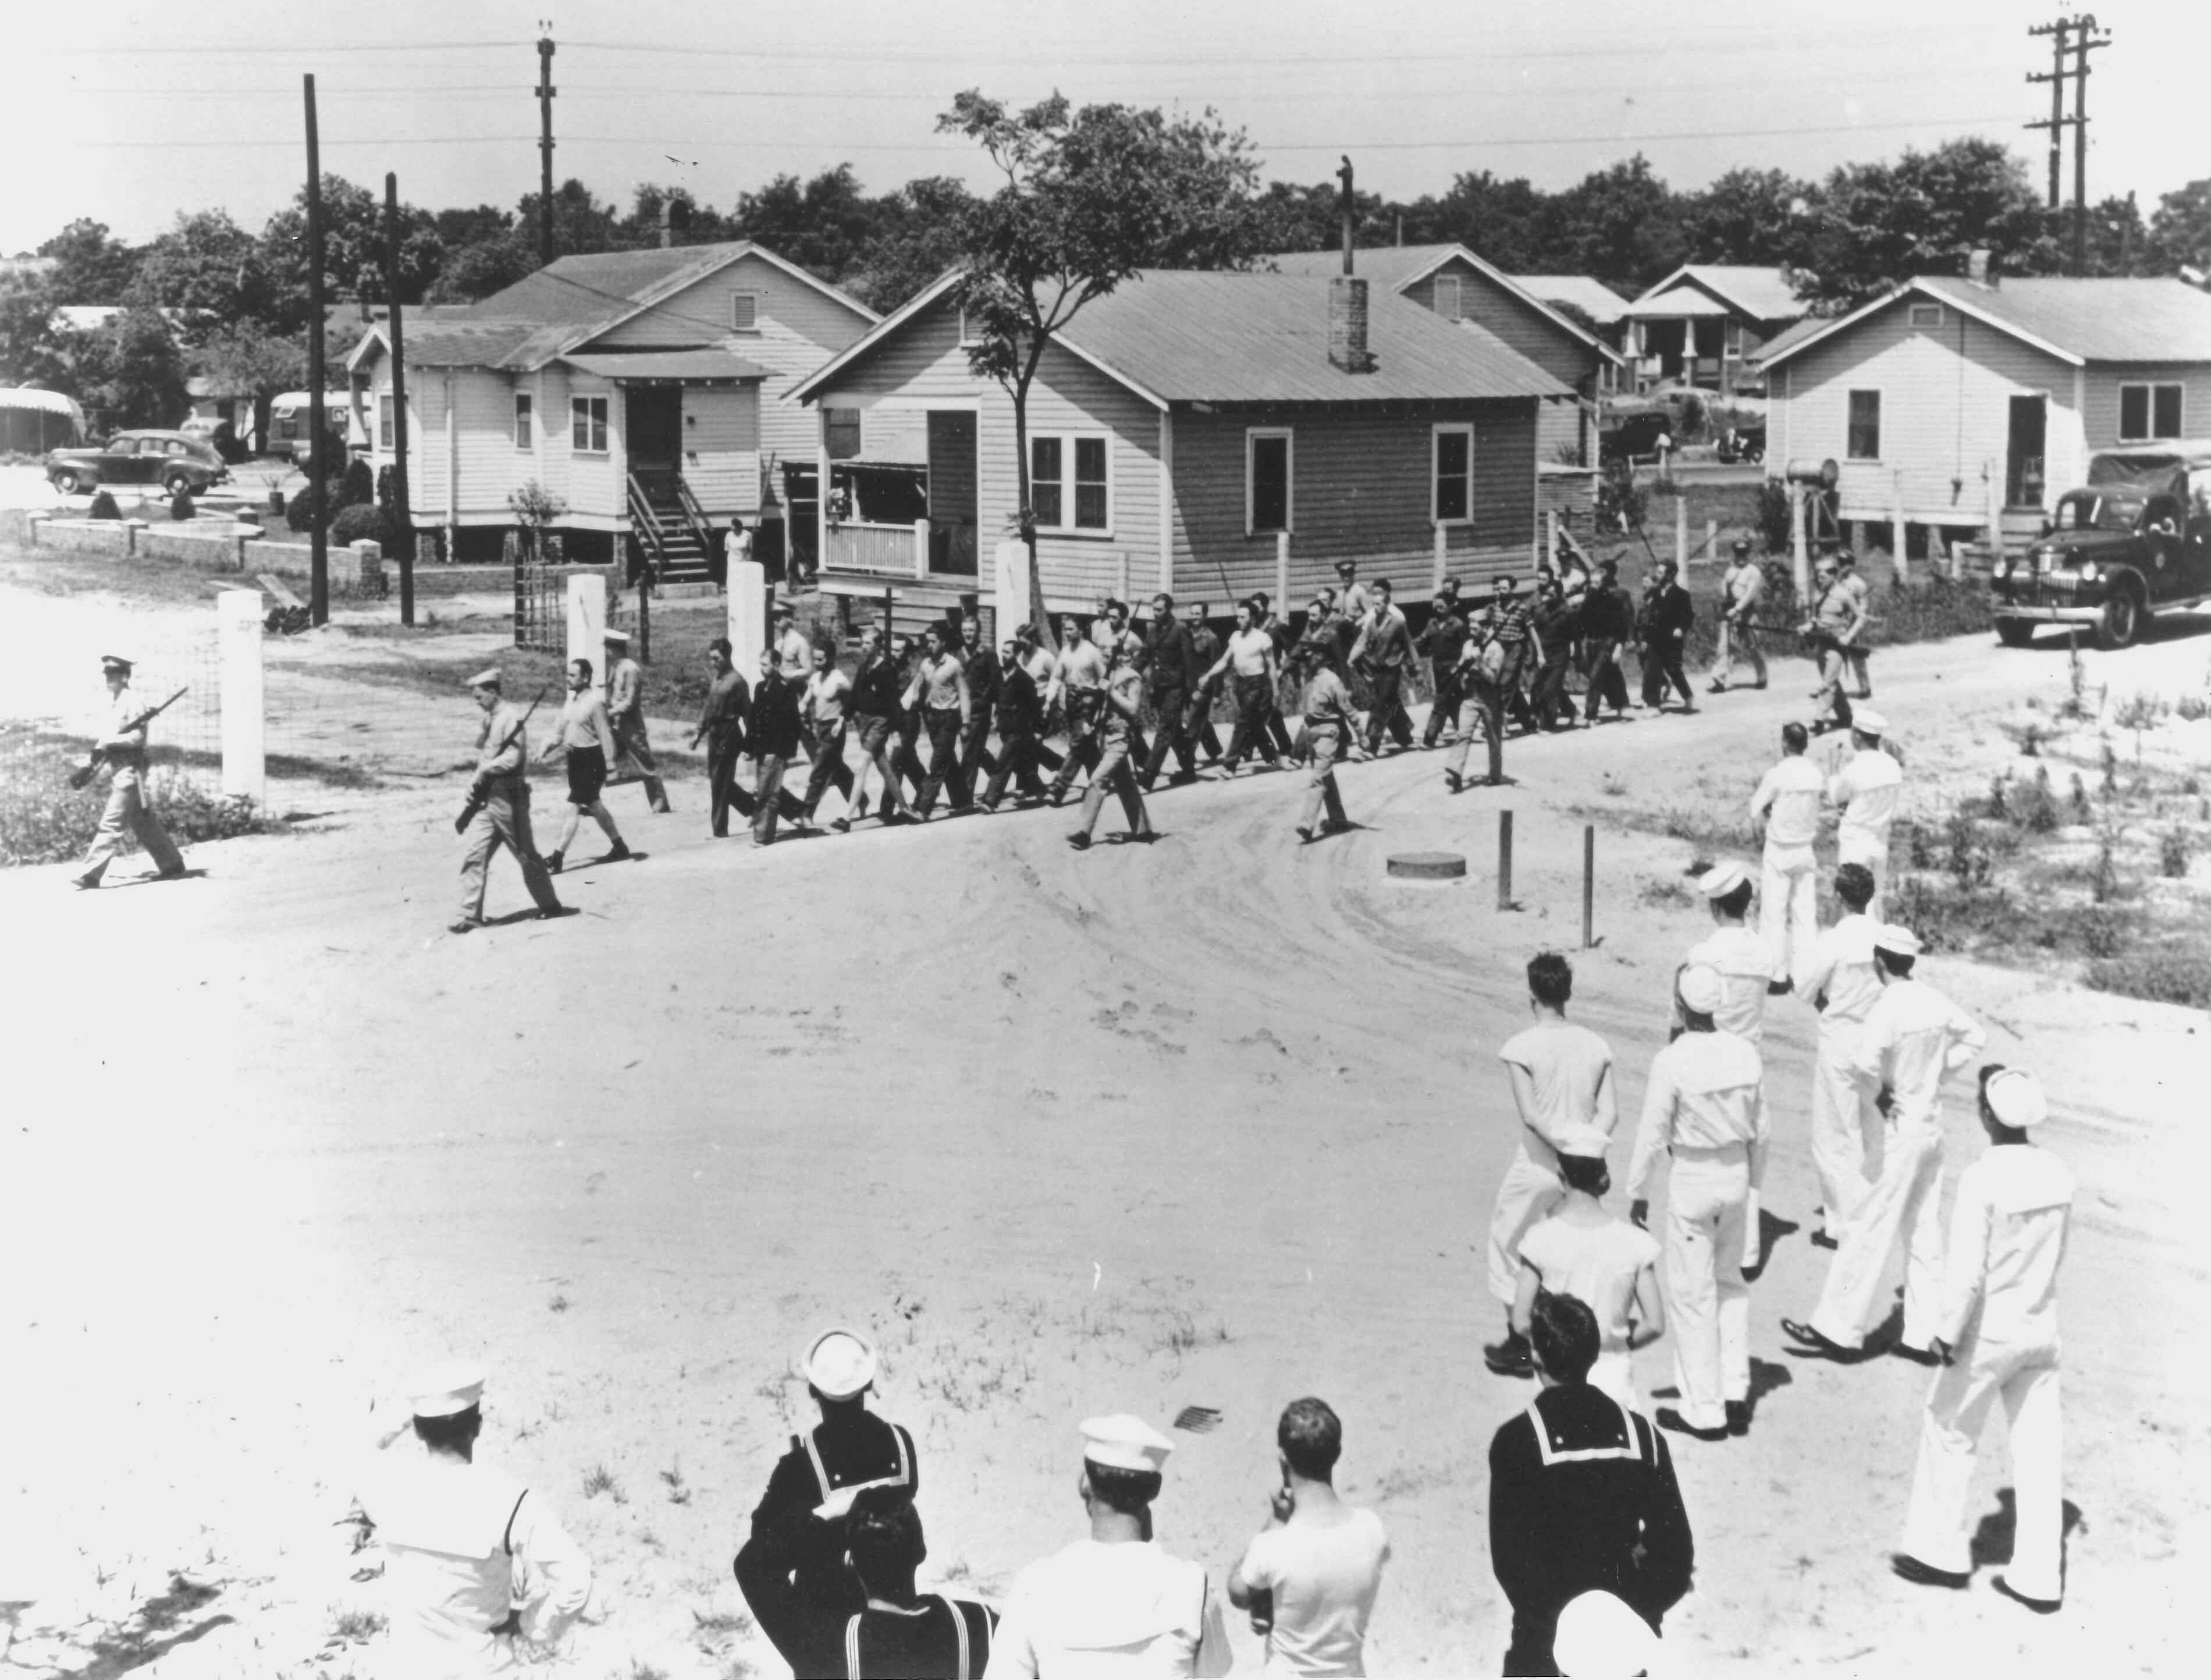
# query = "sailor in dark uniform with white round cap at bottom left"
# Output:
<box><xmin>734</xmin><ymin>1335</ymin><xmax>922</xmax><ymax>1675</ymax></box>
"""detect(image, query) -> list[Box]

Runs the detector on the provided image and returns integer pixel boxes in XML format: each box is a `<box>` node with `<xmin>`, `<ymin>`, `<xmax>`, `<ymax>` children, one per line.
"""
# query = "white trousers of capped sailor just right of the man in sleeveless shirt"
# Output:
<box><xmin>1665</xmin><ymin>1154</ymin><xmax>1751</xmax><ymax>1430</ymax></box>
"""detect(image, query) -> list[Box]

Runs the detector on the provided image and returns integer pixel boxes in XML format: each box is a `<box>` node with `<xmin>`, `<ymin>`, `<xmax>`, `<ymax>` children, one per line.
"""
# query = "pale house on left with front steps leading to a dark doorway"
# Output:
<box><xmin>347</xmin><ymin>241</ymin><xmax>880</xmax><ymax>579</ymax></box>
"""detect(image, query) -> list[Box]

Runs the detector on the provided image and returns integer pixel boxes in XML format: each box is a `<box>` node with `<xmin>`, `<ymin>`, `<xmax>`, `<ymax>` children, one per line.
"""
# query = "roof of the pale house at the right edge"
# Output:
<box><xmin>1760</xmin><ymin>274</ymin><xmax>2211</xmax><ymax>367</ymax></box>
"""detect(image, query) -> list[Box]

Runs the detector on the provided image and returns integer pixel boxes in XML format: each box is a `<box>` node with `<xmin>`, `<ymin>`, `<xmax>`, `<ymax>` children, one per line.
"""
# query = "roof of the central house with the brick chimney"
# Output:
<box><xmin>791</xmin><ymin>270</ymin><xmax>1572</xmax><ymax>409</ymax></box>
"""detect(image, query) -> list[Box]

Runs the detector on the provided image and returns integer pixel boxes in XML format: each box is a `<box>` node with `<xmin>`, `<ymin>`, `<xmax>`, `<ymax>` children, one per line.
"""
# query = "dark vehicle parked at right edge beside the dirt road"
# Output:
<box><xmin>1992</xmin><ymin>440</ymin><xmax>2211</xmax><ymax>647</ymax></box>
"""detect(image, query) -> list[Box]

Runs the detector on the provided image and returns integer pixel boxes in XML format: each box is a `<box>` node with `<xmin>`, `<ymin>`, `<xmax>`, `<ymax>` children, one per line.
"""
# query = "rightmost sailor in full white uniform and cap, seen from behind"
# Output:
<box><xmin>1890</xmin><ymin>1067</ymin><xmax>2074</xmax><ymax>1611</ymax></box>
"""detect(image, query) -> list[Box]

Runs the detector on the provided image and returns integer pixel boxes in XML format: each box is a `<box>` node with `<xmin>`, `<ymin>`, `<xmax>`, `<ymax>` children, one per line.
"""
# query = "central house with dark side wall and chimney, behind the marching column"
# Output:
<box><xmin>794</xmin><ymin>270</ymin><xmax>1574</xmax><ymax>628</ymax></box>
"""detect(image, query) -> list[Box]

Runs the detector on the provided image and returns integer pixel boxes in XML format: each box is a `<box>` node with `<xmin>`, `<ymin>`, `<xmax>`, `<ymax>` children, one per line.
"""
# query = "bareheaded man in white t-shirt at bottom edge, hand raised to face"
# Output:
<box><xmin>1229</xmin><ymin>1399</ymin><xmax>1388</xmax><ymax>1680</ymax></box>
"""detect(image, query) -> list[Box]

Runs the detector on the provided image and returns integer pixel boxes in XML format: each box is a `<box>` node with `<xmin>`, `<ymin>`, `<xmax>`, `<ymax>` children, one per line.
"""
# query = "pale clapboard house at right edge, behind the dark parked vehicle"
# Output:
<box><xmin>1764</xmin><ymin>270</ymin><xmax>2211</xmax><ymax>544</ymax></box>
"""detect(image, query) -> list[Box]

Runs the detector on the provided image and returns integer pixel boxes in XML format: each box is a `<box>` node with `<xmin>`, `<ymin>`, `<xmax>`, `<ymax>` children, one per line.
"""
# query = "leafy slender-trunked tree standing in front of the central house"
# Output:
<box><xmin>937</xmin><ymin>88</ymin><xmax>1265</xmax><ymax>635</ymax></box>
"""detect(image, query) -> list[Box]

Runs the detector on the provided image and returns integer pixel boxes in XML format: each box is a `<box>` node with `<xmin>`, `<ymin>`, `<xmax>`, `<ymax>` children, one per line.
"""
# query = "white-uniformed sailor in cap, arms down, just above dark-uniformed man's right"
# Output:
<box><xmin>1627</xmin><ymin>964</ymin><xmax>1766</xmax><ymax>1441</ymax></box>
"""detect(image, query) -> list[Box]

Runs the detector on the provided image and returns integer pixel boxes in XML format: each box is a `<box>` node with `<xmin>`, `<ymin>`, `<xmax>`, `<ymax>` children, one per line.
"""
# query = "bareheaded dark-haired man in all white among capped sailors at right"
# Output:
<box><xmin>1797</xmin><ymin>864</ymin><xmax>1882</xmax><ymax>1249</ymax></box>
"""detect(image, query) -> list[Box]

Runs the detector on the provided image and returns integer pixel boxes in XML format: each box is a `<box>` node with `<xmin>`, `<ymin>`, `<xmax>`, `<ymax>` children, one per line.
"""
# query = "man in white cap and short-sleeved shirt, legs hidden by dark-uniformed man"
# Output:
<box><xmin>1512</xmin><ymin>1125</ymin><xmax>1665</xmax><ymax>1408</ymax></box>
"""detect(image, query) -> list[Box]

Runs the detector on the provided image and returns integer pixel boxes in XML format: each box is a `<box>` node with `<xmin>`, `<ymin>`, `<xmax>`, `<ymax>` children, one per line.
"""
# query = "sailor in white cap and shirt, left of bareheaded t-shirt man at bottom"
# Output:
<box><xmin>986</xmin><ymin>1412</ymin><xmax>1232</xmax><ymax>1680</ymax></box>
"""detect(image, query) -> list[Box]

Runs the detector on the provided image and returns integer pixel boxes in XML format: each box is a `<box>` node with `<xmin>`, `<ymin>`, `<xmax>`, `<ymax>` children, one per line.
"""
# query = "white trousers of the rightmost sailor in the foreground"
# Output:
<box><xmin>1904</xmin><ymin>1333</ymin><xmax>2065</xmax><ymax>1600</ymax></box>
